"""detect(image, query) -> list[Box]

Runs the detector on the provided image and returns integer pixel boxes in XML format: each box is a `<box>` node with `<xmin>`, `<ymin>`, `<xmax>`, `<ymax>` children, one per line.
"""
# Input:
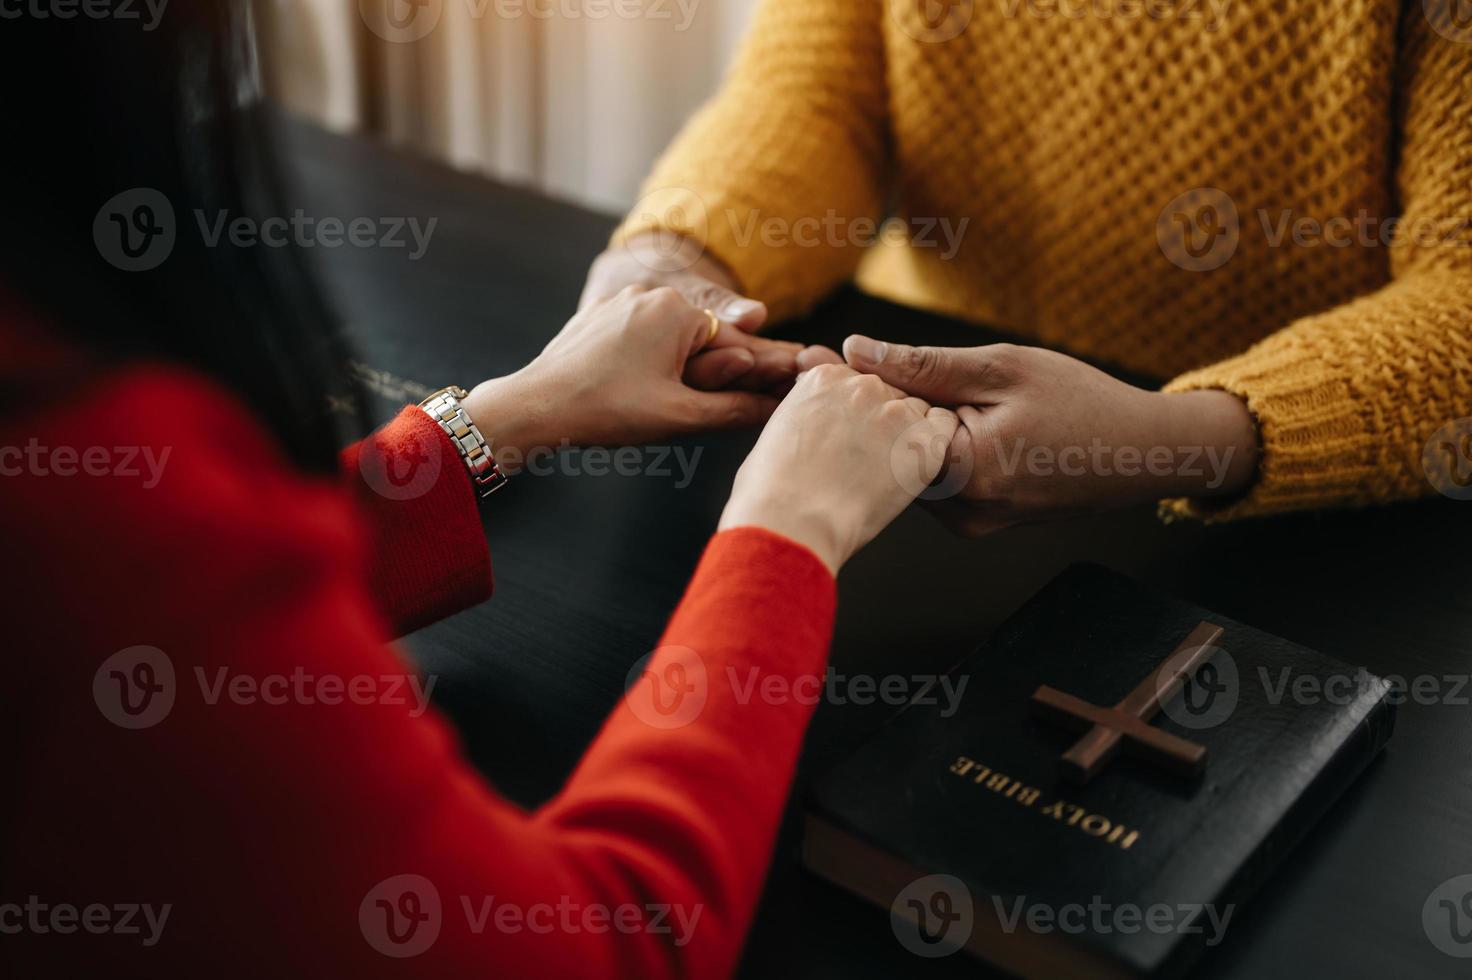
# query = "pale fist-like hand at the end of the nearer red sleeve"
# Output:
<box><xmin>720</xmin><ymin>363</ymin><xmax>957</xmax><ymax>574</ymax></box>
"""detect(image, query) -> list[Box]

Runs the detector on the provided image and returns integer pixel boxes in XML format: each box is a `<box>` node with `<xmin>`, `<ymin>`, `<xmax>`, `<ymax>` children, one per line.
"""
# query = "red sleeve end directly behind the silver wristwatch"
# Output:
<box><xmin>342</xmin><ymin>406</ymin><xmax>493</xmax><ymax>633</ymax></box>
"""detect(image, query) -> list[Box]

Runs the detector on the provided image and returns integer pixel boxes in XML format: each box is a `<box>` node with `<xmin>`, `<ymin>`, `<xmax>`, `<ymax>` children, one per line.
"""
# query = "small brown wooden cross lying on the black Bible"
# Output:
<box><xmin>1032</xmin><ymin>622</ymin><xmax>1222</xmax><ymax>783</ymax></box>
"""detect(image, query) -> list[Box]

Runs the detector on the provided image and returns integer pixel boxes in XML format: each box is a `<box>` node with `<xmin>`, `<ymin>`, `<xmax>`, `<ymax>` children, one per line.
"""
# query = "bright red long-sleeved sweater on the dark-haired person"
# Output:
<box><xmin>0</xmin><ymin>326</ymin><xmax>835</xmax><ymax>977</ymax></box>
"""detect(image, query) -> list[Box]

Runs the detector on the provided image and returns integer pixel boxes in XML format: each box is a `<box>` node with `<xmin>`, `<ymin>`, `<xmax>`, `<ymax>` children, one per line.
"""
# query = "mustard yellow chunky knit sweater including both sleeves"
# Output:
<box><xmin>618</xmin><ymin>0</ymin><xmax>1472</xmax><ymax>516</ymax></box>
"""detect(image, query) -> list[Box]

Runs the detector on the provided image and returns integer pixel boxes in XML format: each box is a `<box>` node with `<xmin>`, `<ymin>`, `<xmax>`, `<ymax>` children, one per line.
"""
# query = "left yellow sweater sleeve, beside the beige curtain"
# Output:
<box><xmin>614</xmin><ymin>0</ymin><xmax>888</xmax><ymax>318</ymax></box>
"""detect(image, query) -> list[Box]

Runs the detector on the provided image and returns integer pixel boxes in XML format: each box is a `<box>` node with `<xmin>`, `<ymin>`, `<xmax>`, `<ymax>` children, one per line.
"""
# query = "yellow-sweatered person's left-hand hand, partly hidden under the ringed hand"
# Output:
<box><xmin>578</xmin><ymin>232</ymin><xmax>802</xmax><ymax>391</ymax></box>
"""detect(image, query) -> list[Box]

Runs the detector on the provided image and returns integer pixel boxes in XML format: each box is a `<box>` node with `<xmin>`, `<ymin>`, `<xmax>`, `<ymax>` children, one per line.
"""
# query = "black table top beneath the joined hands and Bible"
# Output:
<box><xmin>286</xmin><ymin>122</ymin><xmax>1472</xmax><ymax>980</ymax></box>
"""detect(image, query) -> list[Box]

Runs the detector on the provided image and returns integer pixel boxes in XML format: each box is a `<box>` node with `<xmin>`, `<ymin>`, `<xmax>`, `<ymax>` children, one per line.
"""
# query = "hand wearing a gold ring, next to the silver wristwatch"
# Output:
<box><xmin>465</xmin><ymin>285</ymin><xmax>777</xmax><ymax>469</ymax></box>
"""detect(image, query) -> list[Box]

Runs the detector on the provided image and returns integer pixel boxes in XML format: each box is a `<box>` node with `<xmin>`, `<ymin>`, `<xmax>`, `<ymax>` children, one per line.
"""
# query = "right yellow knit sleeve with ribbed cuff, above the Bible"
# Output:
<box><xmin>1161</xmin><ymin>16</ymin><xmax>1472</xmax><ymax>519</ymax></box>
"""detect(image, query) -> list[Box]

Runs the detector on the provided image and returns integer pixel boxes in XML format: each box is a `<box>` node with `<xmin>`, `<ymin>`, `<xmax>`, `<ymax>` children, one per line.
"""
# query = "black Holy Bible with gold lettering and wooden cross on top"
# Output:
<box><xmin>802</xmin><ymin>565</ymin><xmax>1394</xmax><ymax>977</ymax></box>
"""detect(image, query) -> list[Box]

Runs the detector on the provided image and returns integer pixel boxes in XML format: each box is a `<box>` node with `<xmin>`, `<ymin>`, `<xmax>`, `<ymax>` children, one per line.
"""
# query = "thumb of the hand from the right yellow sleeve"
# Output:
<box><xmin>843</xmin><ymin>334</ymin><xmax>1011</xmax><ymax>405</ymax></box>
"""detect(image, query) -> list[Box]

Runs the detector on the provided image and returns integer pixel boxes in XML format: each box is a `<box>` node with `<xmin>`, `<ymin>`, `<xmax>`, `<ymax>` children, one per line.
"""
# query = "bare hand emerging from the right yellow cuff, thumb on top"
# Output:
<box><xmin>843</xmin><ymin>335</ymin><xmax>1257</xmax><ymax>536</ymax></box>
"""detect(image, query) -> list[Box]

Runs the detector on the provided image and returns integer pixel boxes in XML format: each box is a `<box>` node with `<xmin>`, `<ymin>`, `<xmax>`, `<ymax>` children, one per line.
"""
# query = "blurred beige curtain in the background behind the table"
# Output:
<box><xmin>265</xmin><ymin>0</ymin><xmax>755</xmax><ymax>210</ymax></box>
